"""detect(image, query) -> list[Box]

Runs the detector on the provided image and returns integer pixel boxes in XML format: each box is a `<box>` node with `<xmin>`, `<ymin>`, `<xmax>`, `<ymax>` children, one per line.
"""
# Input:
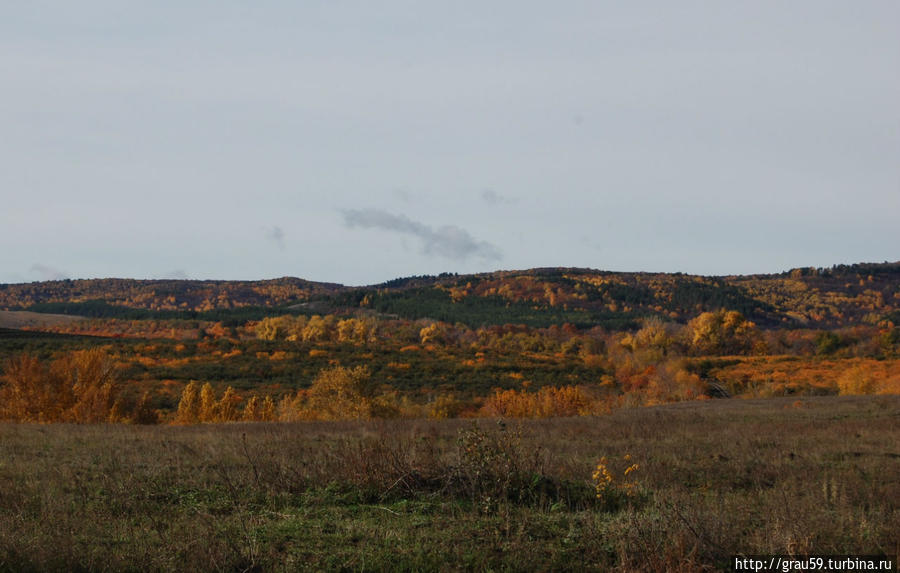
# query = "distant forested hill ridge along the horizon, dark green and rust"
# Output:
<box><xmin>0</xmin><ymin>262</ymin><xmax>900</xmax><ymax>329</ymax></box>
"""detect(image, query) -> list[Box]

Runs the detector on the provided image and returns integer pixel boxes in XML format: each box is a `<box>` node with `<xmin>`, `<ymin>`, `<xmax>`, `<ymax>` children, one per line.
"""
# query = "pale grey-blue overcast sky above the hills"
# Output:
<box><xmin>0</xmin><ymin>0</ymin><xmax>900</xmax><ymax>285</ymax></box>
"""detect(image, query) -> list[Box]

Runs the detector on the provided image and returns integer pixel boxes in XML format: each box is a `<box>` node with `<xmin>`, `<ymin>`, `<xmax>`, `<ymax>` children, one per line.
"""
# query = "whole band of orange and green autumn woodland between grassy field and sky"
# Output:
<box><xmin>0</xmin><ymin>263</ymin><xmax>900</xmax><ymax>424</ymax></box>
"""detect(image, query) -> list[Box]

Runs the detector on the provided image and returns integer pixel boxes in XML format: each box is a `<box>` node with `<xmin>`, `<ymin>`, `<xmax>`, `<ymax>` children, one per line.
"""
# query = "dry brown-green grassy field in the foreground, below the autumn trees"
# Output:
<box><xmin>0</xmin><ymin>396</ymin><xmax>900</xmax><ymax>571</ymax></box>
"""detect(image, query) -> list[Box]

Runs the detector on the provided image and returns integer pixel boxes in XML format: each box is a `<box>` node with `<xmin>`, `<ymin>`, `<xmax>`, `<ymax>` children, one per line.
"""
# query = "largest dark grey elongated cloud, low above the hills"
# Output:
<box><xmin>341</xmin><ymin>209</ymin><xmax>502</xmax><ymax>261</ymax></box>
